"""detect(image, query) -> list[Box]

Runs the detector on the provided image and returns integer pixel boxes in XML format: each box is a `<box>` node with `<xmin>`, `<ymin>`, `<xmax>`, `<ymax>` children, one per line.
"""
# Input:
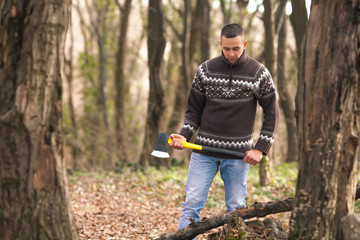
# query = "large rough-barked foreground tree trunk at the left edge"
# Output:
<box><xmin>0</xmin><ymin>0</ymin><xmax>78</xmax><ymax>240</ymax></box>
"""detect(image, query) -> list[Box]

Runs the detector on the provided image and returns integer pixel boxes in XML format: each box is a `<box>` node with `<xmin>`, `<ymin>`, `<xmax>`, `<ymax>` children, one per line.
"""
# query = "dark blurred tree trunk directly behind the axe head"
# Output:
<box><xmin>140</xmin><ymin>0</ymin><xmax>167</xmax><ymax>167</ymax></box>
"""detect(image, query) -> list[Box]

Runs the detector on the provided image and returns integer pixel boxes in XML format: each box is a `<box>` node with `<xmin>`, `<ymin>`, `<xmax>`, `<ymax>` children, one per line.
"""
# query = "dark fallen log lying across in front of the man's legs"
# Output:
<box><xmin>156</xmin><ymin>184</ymin><xmax>360</xmax><ymax>240</ymax></box>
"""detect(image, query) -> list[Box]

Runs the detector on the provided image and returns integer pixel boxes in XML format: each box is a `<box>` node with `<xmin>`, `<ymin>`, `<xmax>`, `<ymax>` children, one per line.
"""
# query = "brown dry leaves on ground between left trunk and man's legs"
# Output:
<box><xmin>69</xmin><ymin>169</ymin><xmax>225</xmax><ymax>240</ymax></box>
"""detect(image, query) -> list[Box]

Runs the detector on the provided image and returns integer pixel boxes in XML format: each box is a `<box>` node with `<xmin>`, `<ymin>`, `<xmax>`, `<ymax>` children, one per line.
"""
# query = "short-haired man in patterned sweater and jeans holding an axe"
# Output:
<box><xmin>170</xmin><ymin>24</ymin><xmax>279</xmax><ymax>229</ymax></box>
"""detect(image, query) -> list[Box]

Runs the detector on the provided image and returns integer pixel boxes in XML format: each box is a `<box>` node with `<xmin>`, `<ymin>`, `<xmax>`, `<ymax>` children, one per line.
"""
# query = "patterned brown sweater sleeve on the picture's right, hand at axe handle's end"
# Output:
<box><xmin>255</xmin><ymin>68</ymin><xmax>280</xmax><ymax>155</ymax></box>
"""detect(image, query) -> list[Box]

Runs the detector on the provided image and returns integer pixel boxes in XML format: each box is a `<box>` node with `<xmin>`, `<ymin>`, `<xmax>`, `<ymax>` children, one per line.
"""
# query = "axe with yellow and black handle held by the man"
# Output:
<box><xmin>151</xmin><ymin>132</ymin><xmax>268</xmax><ymax>160</ymax></box>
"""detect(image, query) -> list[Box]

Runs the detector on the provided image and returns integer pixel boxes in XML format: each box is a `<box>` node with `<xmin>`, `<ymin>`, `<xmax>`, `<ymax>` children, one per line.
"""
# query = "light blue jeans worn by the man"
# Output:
<box><xmin>179</xmin><ymin>153</ymin><xmax>249</xmax><ymax>229</ymax></box>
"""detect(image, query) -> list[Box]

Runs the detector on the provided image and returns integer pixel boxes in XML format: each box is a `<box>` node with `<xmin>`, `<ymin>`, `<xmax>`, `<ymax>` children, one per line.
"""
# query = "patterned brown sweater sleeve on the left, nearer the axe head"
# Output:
<box><xmin>179</xmin><ymin>64</ymin><xmax>205</xmax><ymax>141</ymax></box>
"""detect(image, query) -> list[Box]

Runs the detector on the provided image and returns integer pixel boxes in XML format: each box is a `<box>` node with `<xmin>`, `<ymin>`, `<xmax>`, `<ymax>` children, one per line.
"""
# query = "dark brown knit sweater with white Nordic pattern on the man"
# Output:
<box><xmin>179</xmin><ymin>51</ymin><xmax>279</xmax><ymax>158</ymax></box>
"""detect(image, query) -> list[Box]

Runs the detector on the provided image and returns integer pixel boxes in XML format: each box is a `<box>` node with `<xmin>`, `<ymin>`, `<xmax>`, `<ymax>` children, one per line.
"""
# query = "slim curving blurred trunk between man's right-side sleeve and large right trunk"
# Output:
<box><xmin>277</xmin><ymin>15</ymin><xmax>298</xmax><ymax>162</ymax></box>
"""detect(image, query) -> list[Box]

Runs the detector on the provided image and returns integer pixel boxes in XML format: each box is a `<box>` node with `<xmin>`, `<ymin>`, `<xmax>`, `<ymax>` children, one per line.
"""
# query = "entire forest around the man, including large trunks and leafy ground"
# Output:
<box><xmin>0</xmin><ymin>0</ymin><xmax>360</xmax><ymax>240</ymax></box>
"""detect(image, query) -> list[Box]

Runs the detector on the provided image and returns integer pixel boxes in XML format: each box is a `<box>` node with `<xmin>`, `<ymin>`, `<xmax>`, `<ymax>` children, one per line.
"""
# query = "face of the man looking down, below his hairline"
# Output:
<box><xmin>220</xmin><ymin>36</ymin><xmax>247</xmax><ymax>62</ymax></box>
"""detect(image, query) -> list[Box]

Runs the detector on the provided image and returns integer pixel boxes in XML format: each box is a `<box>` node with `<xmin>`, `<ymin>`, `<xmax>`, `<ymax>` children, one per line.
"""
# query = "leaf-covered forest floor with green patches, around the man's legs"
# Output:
<box><xmin>68</xmin><ymin>164</ymin><xmax>297</xmax><ymax>240</ymax></box>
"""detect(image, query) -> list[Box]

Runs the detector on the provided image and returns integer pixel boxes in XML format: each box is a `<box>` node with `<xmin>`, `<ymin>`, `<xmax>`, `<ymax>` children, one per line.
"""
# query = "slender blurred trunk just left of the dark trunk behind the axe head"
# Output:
<box><xmin>114</xmin><ymin>0</ymin><xmax>131</xmax><ymax>163</ymax></box>
